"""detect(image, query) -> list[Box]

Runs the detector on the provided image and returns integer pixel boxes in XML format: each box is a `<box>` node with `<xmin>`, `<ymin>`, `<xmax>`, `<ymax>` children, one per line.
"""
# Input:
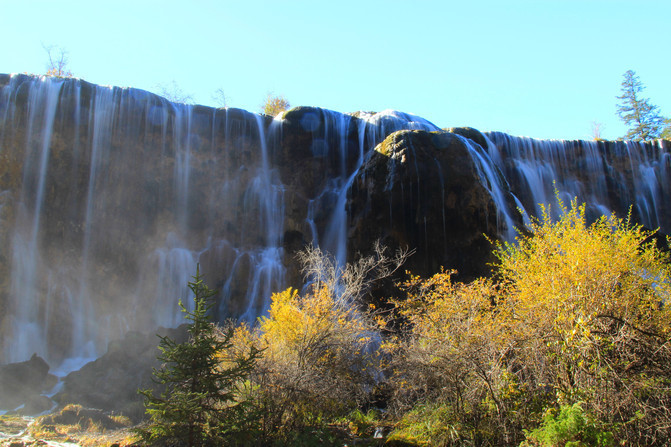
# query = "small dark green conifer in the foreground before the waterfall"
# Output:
<box><xmin>138</xmin><ymin>269</ymin><xmax>259</xmax><ymax>446</ymax></box>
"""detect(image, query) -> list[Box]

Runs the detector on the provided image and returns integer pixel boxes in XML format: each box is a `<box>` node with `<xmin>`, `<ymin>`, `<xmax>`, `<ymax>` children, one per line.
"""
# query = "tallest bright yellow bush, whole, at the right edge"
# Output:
<box><xmin>498</xmin><ymin>201</ymin><xmax>671</xmax><ymax>445</ymax></box>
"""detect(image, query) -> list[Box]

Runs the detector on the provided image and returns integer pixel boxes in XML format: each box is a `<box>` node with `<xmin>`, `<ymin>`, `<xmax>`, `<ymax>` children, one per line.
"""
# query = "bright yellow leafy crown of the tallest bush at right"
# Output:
<box><xmin>497</xmin><ymin>201</ymin><xmax>671</xmax><ymax>343</ymax></box>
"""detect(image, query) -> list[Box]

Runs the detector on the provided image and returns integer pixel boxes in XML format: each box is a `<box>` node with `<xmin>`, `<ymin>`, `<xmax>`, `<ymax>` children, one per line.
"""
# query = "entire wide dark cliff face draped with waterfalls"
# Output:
<box><xmin>0</xmin><ymin>75</ymin><xmax>671</xmax><ymax>364</ymax></box>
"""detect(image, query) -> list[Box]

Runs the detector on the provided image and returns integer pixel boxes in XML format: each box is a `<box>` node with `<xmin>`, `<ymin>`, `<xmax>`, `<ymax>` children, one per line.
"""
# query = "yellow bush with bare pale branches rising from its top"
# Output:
<box><xmin>233</xmin><ymin>246</ymin><xmax>407</xmax><ymax>443</ymax></box>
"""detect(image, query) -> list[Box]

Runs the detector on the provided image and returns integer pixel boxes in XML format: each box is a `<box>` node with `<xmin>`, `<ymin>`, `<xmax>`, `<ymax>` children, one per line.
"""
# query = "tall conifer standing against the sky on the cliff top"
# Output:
<box><xmin>617</xmin><ymin>70</ymin><xmax>664</xmax><ymax>141</ymax></box>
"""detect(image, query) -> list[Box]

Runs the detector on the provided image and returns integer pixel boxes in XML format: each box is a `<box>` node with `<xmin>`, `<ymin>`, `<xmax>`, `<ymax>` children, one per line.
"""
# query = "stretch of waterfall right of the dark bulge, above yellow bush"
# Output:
<box><xmin>485</xmin><ymin>132</ymin><xmax>671</xmax><ymax>234</ymax></box>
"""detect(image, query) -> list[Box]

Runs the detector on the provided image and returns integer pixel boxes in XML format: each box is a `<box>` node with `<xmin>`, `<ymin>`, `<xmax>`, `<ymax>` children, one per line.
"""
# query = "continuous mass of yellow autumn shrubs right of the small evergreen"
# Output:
<box><xmin>138</xmin><ymin>200</ymin><xmax>671</xmax><ymax>447</ymax></box>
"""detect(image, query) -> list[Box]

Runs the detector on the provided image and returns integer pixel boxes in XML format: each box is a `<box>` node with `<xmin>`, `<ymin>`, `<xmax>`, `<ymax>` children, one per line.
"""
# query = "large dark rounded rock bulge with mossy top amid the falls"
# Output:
<box><xmin>348</xmin><ymin>131</ymin><xmax>522</xmax><ymax>279</ymax></box>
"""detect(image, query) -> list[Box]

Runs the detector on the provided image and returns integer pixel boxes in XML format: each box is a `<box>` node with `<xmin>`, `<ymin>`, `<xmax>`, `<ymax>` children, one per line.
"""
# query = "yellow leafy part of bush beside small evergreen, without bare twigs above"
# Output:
<box><xmin>232</xmin><ymin>284</ymin><xmax>378</xmax><ymax>442</ymax></box>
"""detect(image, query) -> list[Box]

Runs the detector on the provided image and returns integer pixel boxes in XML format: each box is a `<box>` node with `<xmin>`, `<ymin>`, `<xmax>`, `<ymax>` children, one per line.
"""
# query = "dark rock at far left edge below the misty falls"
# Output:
<box><xmin>0</xmin><ymin>354</ymin><xmax>54</xmax><ymax>410</ymax></box>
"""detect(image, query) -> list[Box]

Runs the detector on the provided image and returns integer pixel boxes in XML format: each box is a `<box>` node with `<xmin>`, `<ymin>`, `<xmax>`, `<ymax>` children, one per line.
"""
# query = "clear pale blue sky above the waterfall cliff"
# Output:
<box><xmin>0</xmin><ymin>0</ymin><xmax>671</xmax><ymax>139</ymax></box>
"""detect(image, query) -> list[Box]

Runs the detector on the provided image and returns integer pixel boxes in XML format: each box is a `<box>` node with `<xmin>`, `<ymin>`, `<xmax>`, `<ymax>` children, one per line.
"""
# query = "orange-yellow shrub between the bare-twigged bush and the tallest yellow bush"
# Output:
<box><xmin>384</xmin><ymin>271</ymin><xmax>548</xmax><ymax>445</ymax></box>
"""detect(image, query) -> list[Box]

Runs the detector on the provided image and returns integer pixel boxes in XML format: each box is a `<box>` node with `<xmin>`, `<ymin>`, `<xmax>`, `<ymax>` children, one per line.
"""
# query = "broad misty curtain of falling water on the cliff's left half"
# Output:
<box><xmin>0</xmin><ymin>75</ymin><xmax>292</xmax><ymax>363</ymax></box>
